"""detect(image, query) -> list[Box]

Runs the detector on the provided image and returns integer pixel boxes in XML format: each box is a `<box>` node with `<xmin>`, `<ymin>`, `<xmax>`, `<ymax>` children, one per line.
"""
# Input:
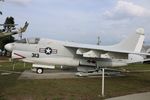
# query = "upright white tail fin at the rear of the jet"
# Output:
<box><xmin>114</xmin><ymin>28</ymin><xmax>145</xmax><ymax>52</ymax></box>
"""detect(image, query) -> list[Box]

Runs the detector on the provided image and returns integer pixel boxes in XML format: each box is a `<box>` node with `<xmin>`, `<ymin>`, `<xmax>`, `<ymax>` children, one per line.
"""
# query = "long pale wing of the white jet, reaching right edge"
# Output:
<box><xmin>64</xmin><ymin>42</ymin><xmax>150</xmax><ymax>57</ymax></box>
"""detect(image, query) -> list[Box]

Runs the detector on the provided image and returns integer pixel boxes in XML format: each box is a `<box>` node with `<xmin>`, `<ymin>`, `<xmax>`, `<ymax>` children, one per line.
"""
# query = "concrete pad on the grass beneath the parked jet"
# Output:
<box><xmin>18</xmin><ymin>69</ymin><xmax>124</xmax><ymax>79</ymax></box>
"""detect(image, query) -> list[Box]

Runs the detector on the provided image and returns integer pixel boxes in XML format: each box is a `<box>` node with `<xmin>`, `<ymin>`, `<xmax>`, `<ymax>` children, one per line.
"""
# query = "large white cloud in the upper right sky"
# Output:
<box><xmin>104</xmin><ymin>0</ymin><xmax>150</xmax><ymax>19</ymax></box>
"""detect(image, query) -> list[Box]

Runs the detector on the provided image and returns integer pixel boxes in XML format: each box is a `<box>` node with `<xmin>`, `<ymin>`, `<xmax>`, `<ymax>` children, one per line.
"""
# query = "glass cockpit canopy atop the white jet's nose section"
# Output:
<box><xmin>16</xmin><ymin>38</ymin><xmax>40</xmax><ymax>44</ymax></box>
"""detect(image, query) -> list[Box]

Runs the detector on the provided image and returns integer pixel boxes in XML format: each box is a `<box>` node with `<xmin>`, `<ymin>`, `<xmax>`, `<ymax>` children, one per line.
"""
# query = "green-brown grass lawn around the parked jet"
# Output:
<box><xmin>0</xmin><ymin>62</ymin><xmax>150</xmax><ymax>100</ymax></box>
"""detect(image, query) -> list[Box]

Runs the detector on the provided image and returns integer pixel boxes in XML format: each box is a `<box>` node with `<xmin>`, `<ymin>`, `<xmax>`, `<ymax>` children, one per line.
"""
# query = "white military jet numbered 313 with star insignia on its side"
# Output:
<box><xmin>5</xmin><ymin>28</ymin><xmax>149</xmax><ymax>73</ymax></box>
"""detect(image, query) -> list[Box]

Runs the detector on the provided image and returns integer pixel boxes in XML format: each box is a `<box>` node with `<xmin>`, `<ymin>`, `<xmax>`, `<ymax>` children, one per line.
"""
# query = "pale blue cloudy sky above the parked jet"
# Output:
<box><xmin>0</xmin><ymin>0</ymin><xmax>150</xmax><ymax>44</ymax></box>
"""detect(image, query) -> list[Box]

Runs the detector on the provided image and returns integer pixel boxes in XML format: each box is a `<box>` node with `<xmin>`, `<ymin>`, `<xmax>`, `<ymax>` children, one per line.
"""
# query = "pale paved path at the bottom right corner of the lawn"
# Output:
<box><xmin>105</xmin><ymin>92</ymin><xmax>150</xmax><ymax>100</ymax></box>
